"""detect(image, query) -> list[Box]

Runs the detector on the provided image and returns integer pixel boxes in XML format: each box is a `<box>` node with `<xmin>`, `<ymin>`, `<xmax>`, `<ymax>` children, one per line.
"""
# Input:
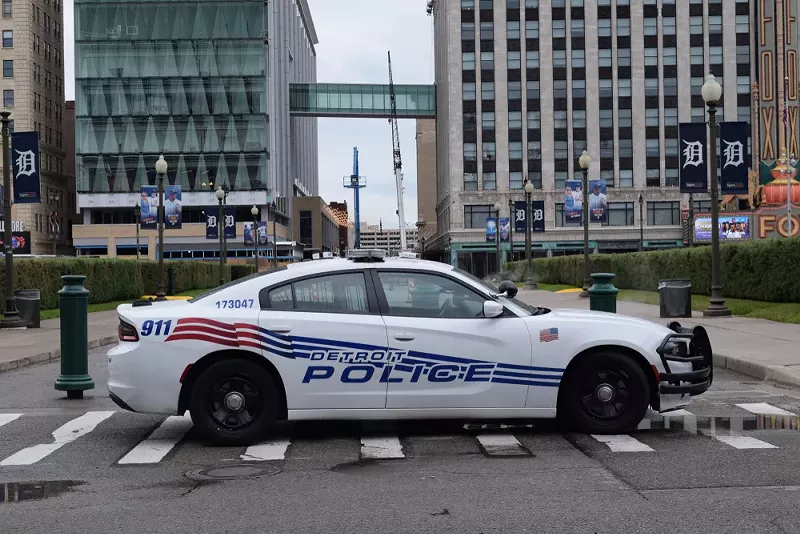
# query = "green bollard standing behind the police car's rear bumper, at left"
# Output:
<box><xmin>55</xmin><ymin>275</ymin><xmax>94</xmax><ymax>399</ymax></box>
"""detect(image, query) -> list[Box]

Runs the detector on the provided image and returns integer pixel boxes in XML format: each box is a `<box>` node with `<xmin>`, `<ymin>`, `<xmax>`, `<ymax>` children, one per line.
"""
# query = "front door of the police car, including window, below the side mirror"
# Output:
<box><xmin>373</xmin><ymin>269</ymin><xmax>532</xmax><ymax>409</ymax></box>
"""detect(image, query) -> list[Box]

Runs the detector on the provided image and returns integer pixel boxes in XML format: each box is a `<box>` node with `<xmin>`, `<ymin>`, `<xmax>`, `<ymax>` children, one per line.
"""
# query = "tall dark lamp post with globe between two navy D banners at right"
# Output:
<box><xmin>702</xmin><ymin>74</ymin><xmax>731</xmax><ymax>317</ymax></box>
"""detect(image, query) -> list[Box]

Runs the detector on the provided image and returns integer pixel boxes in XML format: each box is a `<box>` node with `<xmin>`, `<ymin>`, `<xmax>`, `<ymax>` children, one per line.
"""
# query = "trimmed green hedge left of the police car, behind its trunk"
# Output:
<box><xmin>0</xmin><ymin>258</ymin><xmax>255</xmax><ymax>309</ymax></box>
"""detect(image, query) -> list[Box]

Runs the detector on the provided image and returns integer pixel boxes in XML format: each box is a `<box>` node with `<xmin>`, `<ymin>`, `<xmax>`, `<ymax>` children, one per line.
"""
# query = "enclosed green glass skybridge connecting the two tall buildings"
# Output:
<box><xmin>289</xmin><ymin>83</ymin><xmax>436</xmax><ymax>119</ymax></box>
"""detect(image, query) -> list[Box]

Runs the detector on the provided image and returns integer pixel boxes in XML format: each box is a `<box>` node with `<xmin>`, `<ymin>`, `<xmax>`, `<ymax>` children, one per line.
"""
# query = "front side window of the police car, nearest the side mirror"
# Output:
<box><xmin>378</xmin><ymin>272</ymin><xmax>486</xmax><ymax>319</ymax></box>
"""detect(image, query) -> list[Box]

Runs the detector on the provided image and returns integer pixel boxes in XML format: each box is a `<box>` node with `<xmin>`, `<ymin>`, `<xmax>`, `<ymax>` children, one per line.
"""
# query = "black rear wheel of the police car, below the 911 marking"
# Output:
<box><xmin>189</xmin><ymin>360</ymin><xmax>278</xmax><ymax>446</ymax></box>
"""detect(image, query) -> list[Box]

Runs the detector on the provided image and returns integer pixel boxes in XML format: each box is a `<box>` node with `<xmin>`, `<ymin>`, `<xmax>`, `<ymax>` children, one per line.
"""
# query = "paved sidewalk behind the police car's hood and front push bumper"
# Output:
<box><xmin>517</xmin><ymin>289</ymin><xmax>800</xmax><ymax>386</ymax></box>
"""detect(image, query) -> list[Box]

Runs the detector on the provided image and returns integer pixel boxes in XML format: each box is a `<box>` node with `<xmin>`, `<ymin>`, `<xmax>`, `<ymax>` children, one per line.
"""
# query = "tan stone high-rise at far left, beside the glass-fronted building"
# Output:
<box><xmin>0</xmin><ymin>0</ymin><xmax>69</xmax><ymax>255</ymax></box>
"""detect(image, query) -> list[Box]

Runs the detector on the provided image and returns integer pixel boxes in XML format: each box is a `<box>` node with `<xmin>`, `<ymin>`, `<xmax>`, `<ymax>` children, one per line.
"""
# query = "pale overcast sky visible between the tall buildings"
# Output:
<box><xmin>64</xmin><ymin>0</ymin><xmax>433</xmax><ymax>228</ymax></box>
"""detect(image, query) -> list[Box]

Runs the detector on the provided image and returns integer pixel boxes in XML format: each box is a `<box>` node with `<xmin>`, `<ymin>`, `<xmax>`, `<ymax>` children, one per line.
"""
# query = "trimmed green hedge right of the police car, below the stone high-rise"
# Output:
<box><xmin>507</xmin><ymin>237</ymin><xmax>800</xmax><ymax>302</ymax></box>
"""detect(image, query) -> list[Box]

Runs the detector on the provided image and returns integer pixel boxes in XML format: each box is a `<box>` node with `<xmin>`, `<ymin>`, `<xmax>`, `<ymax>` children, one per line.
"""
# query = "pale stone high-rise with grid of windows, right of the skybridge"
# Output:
<box><xmin>426</xmin><ymin>0</ymin><xmax>752</xmax><ymax>275</ymax></box>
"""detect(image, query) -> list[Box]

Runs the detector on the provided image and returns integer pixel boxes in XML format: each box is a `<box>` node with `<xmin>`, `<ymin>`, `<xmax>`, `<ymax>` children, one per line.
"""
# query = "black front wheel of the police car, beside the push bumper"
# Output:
<box><xmin>558</xmin><ymin>351</ymin><xmax>650</xmax><ymax>434</ymax></box>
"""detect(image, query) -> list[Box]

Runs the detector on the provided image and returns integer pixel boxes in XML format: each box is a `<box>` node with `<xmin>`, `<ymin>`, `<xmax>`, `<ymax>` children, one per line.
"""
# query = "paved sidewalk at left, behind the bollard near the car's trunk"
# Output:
<box><xmin>0</xmin><ymin>311</ymin><xmax>119</xmax><ymax>373</ymax></box>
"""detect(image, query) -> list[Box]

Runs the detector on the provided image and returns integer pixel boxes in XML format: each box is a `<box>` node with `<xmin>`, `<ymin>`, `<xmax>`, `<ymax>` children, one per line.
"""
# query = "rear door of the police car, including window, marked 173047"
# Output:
<box><xmin>259</xmin><ymin>269</ymin><xmax>387</xmax><ymax>410</ymax></box>
